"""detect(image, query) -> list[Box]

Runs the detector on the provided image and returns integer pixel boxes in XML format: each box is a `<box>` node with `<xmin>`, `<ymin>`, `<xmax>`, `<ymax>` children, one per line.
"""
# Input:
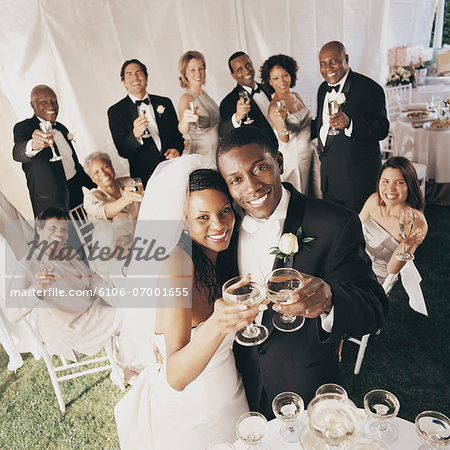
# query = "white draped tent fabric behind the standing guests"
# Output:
<box><xmin>0</xmin><ymin>0</ymin><xmax>437</xmax><ymax>217</ymax></box>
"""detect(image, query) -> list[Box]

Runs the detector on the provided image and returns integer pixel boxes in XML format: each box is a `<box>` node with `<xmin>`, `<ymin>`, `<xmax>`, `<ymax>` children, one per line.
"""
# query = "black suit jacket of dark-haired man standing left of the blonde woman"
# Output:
<box><xmin>108</xmin><ymin>95</ymin><xmax>184</xmax><ymax>187</ymax></box>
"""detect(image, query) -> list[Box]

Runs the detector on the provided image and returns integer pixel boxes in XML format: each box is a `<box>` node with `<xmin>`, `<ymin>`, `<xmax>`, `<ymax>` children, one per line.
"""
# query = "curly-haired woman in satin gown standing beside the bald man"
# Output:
<box><xmin>261</xmin><ymin>55</ymin><xmax>320</xmax><ymax>196</ymax></box>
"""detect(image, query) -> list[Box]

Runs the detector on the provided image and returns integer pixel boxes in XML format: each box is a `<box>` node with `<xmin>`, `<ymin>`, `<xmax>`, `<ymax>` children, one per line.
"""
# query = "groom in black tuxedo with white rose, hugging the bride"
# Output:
<box><xmin>217</xmin><ymin>127</ymin><xmax>388</xmax><ymax>417</ymax></box>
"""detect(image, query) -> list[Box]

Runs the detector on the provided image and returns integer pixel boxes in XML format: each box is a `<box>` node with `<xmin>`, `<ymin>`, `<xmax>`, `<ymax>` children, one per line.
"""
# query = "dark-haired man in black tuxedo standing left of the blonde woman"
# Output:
<box><xmin>108</xmin><ymin>59</ymin><xmax>184</xmax><ymax>187</ymax></box>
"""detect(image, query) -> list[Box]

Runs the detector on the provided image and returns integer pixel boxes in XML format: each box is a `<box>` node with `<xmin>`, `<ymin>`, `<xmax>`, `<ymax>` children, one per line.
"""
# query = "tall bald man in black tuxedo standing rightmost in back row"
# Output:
<box><xmin>312</xmin><ymin>41</ymin><xmax>389</xmax><ymax>213</ymax></box>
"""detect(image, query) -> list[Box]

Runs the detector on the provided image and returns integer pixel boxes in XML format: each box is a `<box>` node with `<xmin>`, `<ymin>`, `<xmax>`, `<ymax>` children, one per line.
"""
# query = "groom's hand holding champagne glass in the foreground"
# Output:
<box><xmin>272</xmin><ymin>274</ymin><xmax>333</xmax><ymax>319</ymax></box>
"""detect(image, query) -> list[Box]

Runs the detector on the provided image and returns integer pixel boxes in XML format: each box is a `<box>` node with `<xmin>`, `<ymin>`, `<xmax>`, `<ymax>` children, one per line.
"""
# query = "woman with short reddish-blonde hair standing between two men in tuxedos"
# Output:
<box><xmin>178</xmin><ymin>50</ymin><xmax>220</xmax><ymax>161</ymax></box>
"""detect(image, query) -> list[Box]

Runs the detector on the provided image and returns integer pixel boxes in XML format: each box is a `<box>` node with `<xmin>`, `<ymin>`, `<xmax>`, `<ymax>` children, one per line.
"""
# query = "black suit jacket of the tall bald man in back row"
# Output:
<box><xmin>312</xmin><ymin>70</ymin><xmax>389</xmax><ymax>213</ymax></box>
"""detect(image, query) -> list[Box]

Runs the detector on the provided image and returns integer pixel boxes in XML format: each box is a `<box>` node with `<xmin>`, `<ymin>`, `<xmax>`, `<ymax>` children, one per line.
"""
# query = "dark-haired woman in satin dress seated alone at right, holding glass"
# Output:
<box><xmin>359</xmin><ymin>156</ymin><xmax>428</xmax><ymax>284</ymax></box>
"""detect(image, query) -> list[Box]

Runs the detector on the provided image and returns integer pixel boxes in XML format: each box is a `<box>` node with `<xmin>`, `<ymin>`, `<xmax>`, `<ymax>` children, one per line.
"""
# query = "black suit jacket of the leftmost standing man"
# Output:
<box><xmin>13</xmin><ymin>115</ymin><xmax>95</xmax><ymax>217</ymax></box>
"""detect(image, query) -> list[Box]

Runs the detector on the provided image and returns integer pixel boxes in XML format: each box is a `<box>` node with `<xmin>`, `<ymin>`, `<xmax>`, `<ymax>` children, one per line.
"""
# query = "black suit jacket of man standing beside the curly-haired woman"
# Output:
<box><xmin>219</xmin><ymin>84</ymin><xmax>278</xmax><ymax>146</ymax></box>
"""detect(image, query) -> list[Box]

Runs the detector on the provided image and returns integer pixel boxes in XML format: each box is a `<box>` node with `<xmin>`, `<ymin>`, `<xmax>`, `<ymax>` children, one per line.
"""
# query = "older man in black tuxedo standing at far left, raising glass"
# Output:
<box><xmin>13</xmin><ymin>85</ymin><xmax>95</xmax><ymax>217</ymax></box>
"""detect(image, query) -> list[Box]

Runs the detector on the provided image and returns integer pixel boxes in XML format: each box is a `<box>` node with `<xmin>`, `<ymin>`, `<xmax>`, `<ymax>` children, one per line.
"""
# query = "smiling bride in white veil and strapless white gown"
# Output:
<box><xmin>115</xmin><ymin>155</ymin><xmax>266</xmax><ymax>450</ymax></box>
